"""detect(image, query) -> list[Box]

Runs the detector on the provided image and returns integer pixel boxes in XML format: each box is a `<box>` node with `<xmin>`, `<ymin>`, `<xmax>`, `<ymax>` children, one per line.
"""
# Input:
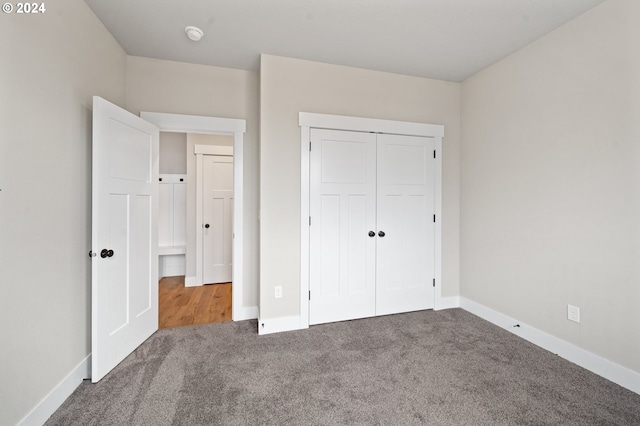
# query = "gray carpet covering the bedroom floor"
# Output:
<box><xmin>46</xmin><ymin>309</ymin><xmax>640</xmax><ymax>425</ymax></box>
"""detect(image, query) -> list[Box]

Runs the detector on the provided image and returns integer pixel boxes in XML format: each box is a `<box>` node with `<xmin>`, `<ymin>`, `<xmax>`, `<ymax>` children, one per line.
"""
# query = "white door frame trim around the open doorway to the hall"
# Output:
<box><xmin>140</xmin><ymin>111</ymin><xmax>249</xmax><ymax>321</ymax></box>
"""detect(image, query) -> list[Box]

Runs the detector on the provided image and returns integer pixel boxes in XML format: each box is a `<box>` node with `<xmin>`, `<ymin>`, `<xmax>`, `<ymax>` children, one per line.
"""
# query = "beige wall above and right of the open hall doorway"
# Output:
<box><xmin>126</xmin><ymin>56</ymin><xmax>259</xmax><ymax>307</ymax></box>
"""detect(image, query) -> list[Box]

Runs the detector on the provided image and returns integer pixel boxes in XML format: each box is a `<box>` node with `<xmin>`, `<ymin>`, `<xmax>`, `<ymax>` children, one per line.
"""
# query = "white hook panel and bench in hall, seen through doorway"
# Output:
<box><xmin>158</xmin><ymin>174</ymin><xmax>187</xmax><ymax>278</ymax></box>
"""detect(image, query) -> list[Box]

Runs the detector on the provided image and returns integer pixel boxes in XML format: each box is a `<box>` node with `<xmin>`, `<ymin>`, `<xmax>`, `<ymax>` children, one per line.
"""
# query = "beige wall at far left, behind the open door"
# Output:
<box><xmin>0</xmin><ymin>0</ymin><xmax>126</xmax><ymax>425</ymax></box>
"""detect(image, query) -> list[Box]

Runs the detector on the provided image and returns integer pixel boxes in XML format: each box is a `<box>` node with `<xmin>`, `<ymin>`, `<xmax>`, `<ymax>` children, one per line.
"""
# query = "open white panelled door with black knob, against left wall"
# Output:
<box><xmin>91</xmin><ymin>96</ymin><xmax>159</xmax><ymax>382</ymax></box>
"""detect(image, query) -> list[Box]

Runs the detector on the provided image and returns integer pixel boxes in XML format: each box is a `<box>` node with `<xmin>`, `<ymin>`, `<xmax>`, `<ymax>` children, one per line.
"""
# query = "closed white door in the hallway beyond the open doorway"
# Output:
<box><xmin>202</xmin><ymin>155</ymin><xmax>233</xmax><ymax>284</ymax></box>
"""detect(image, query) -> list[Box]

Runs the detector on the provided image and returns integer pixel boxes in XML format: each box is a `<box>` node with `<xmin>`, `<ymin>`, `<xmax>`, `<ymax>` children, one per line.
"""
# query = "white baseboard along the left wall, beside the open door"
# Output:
<box><xmin>18</xmin><ymin>355</ymin><xmax>91</xmax><ymax>426</ymax></box>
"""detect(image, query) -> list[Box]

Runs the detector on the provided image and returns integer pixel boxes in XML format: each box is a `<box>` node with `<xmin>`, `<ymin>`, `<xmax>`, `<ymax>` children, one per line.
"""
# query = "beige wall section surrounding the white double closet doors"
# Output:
<box><xmin>260</xmin><ymin>55</ymin><xmax>460</xmax><ymax>319</ymax></box>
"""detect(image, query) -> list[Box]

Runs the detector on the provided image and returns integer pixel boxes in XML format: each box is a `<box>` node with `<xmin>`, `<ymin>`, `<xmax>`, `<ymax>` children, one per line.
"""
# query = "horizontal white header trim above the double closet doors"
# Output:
<box><xmin>298</xmin><ymin>112</ymin><xmax>444</xmax><ymax>138</ymax></box>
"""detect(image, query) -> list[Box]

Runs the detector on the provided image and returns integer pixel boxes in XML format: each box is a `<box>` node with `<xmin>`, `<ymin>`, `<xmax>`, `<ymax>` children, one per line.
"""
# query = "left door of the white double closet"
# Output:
<box><xmin>308</xmin><ymin>129</ymin><xmax>376</xmax><ymax>324</ymax></box>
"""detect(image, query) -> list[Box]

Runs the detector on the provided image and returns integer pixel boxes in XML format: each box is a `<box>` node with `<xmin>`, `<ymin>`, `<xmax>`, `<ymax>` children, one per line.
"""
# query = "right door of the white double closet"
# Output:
<box><xmin>376</xmin><ymin>134</ymin><xmax>435</xmax><ymax>315</ymax></box>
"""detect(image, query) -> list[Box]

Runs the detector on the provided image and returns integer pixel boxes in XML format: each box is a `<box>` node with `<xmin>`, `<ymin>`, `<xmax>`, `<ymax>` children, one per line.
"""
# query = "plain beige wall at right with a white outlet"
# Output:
<box><xmin>461</xmin><ymin>0</ymin><xmax>640</xmax><ymax>372</ymax></box>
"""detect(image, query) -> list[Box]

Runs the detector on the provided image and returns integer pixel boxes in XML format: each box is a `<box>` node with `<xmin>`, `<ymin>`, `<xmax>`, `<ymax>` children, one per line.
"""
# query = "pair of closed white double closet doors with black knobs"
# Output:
<box><xmin>309</xmin><ymin>129</ymin><xmax>435</xmax><ymax>324</ymax></box>
